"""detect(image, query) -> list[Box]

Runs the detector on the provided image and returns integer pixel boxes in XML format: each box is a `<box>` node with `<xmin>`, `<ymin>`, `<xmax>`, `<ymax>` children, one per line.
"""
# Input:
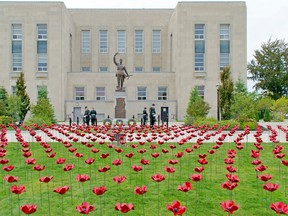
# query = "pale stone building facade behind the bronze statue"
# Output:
<box><xmin>0</xmin><ymin>1</ymin><xmax>247</xmax><ymax>121</ymax></box>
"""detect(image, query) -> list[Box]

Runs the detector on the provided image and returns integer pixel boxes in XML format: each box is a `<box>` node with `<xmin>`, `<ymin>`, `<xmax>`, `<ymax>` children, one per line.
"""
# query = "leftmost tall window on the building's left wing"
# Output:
<box><xmin>12</xmin><ymin>24</ymin><xmax>22</xmax><ymax>72</ymax></box>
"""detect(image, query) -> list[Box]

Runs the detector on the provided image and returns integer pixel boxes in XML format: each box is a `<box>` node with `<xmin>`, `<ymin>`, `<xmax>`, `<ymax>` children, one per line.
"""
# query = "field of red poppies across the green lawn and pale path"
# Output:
<box><xmin>0</xmin><ymin>122</ymin><xmax>288</xmax><ymax>216</ymax></box>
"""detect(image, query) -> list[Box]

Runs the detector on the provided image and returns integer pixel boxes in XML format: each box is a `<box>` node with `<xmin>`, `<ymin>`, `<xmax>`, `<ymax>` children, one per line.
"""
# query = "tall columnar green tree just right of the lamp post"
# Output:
<box><xmin>219</xmin><ymin>67</ymin><xmax>234</xmax><ymax>120</ymax></box>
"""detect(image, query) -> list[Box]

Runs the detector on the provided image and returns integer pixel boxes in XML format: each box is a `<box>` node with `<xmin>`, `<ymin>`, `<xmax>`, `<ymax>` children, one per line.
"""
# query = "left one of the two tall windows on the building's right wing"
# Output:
<box><xmin>194</xmin><ymin>24</ymin><xmax>205</xmax><ymax>71</ymax></box>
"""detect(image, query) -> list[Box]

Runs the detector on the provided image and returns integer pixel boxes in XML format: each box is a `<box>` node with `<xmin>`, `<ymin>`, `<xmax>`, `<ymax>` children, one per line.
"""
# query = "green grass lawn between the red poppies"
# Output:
<box><xmin>0</xmin><ymin>129</ymin><xmax>288</xmax><ymax>216</ymax></box>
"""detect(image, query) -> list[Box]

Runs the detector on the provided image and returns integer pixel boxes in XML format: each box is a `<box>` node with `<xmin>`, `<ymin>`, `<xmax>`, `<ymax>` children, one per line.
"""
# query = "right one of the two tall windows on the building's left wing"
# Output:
<box><xmin>37</xmin><ymin>24</ymin><xmax>47</xmax><ymax>72</ymax></box>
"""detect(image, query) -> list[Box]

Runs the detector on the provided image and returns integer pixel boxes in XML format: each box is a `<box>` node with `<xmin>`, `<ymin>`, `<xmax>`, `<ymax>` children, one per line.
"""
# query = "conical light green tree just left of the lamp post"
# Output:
<box><xmin>186</xmin><ymin>87</ymin><xmax>210</xmax><ymax>123</ymax></box>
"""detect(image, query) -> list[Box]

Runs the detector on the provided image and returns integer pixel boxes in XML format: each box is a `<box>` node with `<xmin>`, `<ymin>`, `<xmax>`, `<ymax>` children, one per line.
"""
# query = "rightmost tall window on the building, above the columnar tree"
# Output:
<box><xmin>220</xmin><ymin>24</ymin><xmax>230</xmax><ymax>70</ymax></box>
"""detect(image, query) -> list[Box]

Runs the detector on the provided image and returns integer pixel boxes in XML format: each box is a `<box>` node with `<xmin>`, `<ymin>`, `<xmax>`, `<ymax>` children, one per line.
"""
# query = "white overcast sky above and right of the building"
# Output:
<box><xmin>6</xmin><ymin>0</ymin><xmax>288</xmax><ymax>91</ymax></box>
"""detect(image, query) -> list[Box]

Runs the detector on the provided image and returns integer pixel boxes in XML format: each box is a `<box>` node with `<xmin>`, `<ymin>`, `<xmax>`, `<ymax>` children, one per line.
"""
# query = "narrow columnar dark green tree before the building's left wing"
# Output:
<box><xmin>16</xmin><ymin>72</ymin><xmax>30</xmax><ymax>122</ymax></box>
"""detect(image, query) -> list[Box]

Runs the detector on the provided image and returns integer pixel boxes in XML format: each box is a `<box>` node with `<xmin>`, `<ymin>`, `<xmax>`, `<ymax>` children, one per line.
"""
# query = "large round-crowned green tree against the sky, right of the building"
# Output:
<box><xmin>248</xmin><ymin>38</ymin><xmax>288</xmax><ymax>100</ymax></box>
